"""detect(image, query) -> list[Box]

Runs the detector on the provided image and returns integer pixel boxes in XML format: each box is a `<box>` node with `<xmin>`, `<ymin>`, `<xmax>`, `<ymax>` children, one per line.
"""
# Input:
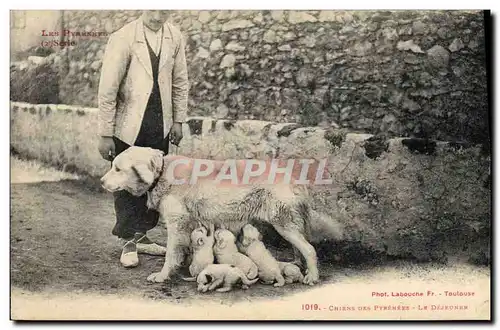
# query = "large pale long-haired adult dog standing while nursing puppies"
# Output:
<box><xmin>101</xmin><ymin>147</ymin><xmax>341</xmax><ymax>285</ymax></box>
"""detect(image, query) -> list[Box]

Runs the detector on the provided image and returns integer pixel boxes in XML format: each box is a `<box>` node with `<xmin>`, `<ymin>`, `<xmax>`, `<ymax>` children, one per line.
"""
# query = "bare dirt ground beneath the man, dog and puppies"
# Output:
<box><xmin>10</xmin><ymin>158</ymin><xmax>490</xmax><ymax>320</ymax></box>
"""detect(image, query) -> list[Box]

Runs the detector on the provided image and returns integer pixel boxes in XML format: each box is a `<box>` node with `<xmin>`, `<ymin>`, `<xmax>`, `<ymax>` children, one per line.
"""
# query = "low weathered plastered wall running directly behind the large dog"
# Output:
<box><xmin>11</xmin><ymin>103</ymin><xmax>491</xmax><ymax>263</ymax></box>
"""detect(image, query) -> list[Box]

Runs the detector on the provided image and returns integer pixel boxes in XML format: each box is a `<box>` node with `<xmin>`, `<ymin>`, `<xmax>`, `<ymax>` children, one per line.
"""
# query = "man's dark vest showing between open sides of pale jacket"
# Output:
<box><xmin>134</xmin><ymin>30</ymin><xmax>164</xmax><ymax>149</ymax></box>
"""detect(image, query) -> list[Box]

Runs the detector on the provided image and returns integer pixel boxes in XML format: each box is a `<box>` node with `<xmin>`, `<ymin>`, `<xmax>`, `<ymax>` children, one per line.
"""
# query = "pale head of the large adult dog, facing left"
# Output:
<box><xmin>101</xmin><ymin>147</ymin><xmax>164</xmax><ymax>196</ymax></box>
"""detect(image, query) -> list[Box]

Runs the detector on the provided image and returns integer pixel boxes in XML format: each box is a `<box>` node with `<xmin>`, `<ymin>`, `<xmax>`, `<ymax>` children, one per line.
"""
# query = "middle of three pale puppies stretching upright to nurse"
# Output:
<box><xmin>214</xmin><ymin>229</ymin><xmax>258</xmax><ymax>280</ymax></box>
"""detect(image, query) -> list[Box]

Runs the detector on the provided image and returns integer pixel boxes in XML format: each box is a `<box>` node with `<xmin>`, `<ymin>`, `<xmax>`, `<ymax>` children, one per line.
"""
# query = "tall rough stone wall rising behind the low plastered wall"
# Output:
<box><xmin>11</xmin><ymin>11</ymin><xmax>489</xmax><ymax>143</ymax></box>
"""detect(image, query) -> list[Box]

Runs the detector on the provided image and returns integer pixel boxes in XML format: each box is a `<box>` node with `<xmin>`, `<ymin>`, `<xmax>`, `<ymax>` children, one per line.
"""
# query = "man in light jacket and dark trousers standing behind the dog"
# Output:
<box><xmin>98</xmin><ymin>11</ymin><xmax>188</xmax><ymax>267</ymax></box>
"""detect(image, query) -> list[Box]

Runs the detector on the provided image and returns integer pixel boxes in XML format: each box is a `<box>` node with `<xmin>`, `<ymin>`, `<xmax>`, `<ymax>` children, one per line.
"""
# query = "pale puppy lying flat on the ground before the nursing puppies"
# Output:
<box><xmin>196</xmin><ymin>264</ymin><xmax>258</xmax><ymax>292</ymax></box>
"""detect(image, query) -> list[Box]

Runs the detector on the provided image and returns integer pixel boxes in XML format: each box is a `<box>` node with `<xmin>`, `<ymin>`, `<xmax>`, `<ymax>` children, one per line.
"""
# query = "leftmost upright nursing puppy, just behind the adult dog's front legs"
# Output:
<box><xmin>184</xmin><ymin>223</ymin><xmax>215</xmax><ymax>282</ymax></box>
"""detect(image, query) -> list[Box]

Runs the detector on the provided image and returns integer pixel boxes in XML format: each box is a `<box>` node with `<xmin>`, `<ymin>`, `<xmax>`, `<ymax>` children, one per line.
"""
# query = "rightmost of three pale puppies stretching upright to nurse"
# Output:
<box><xmin>238</xmin><ymin>224</ymin><xmax>285</xmax><ymax>287</ymax></box>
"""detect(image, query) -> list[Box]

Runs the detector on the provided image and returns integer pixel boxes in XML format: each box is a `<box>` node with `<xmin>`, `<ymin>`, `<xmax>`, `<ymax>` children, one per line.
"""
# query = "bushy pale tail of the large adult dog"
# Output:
<box><xmin>309</xmin><ymin>208</ymin><xmax>344</xmax><ymax>242</ymax></box>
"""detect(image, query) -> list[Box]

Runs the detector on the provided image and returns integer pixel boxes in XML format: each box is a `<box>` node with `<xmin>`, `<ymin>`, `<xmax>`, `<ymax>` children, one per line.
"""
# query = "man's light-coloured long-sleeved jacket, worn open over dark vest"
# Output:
<box><xmin>98</xmin><ymin>18</ymin><xmax>189</xmax><ymax>145</ymax></box>
